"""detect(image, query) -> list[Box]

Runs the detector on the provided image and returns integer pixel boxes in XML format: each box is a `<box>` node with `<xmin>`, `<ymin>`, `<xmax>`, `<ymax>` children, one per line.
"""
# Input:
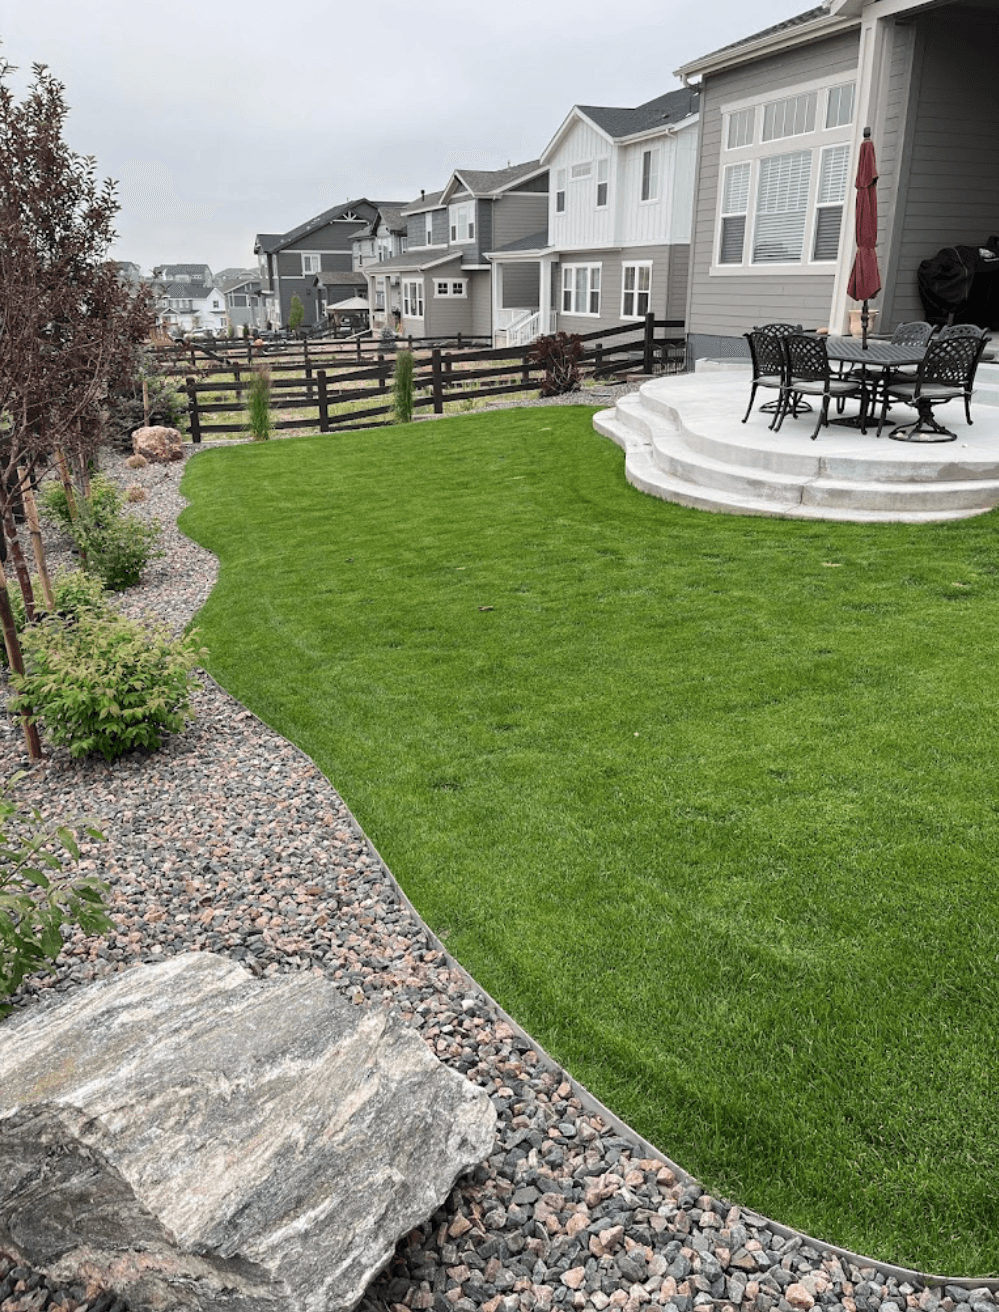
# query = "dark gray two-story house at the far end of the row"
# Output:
<box><xmin>253</xmin><ymin>198</ymin><xmax>398</xmax><ymax>328</ymax></box>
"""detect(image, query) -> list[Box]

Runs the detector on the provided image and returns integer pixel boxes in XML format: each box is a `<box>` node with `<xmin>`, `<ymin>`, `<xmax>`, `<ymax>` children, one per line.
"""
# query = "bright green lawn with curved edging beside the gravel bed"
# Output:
<box><xmin>181</xmin><ymin>407</ymin><xmax>999</xmax><ymax>1274</ymax></box>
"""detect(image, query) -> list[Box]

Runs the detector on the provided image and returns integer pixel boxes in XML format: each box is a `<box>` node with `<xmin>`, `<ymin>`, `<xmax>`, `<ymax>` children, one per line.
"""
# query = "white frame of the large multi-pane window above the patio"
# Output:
<box><xmin>710</xmin><ymin>73</ymin><xmax>856</xmax><ymax>277</ymax></box>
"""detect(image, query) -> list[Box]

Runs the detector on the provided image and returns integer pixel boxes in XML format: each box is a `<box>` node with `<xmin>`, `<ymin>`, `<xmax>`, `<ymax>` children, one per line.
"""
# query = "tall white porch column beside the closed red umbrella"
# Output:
<box><xmin>828</xmin><ymin>5</ymin><xmax>895</xmax><ymax>336</ymax></box>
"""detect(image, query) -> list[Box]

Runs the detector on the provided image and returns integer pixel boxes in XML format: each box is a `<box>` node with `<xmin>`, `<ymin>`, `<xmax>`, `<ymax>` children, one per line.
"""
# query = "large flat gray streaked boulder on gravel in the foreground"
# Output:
<box><xmin>0</xmin><ymin>953</ymin><xmax>496</xmax><ymax>1312</ymax></box>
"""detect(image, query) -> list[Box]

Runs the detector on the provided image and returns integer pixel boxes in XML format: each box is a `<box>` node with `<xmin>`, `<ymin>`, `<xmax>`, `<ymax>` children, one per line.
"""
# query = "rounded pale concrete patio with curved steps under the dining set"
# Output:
<box><xmin>593</xmin><ymin>361</ymin><xmax>999</xmax><ymax>523</ymax></box>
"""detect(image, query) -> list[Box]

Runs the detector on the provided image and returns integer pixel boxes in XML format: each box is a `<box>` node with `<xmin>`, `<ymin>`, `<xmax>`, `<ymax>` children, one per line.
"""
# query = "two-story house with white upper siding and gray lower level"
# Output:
<box><xmin>488</xmin><ymin>87</ymin><xmax>698</xmax><ymax>345</ymax></box>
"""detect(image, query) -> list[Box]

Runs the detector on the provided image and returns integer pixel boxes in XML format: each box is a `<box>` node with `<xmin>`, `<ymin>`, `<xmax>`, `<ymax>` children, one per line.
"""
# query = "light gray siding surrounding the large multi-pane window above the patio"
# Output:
<box><xmin>687</xmin><ymin>33</ymin><xmax>860</xmax><ymax>357</ymax></box>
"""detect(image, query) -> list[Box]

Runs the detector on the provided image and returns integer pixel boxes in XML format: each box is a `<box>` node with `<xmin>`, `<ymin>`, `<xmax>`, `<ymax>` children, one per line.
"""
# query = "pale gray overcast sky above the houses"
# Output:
<box><xmin>0</xmin><ymin>0</ymin><xmax>814</xmax><ymax>272</ymax></box>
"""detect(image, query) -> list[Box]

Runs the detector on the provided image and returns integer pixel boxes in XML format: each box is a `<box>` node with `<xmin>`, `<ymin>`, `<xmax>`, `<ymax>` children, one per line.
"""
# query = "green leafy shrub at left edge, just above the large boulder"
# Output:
<box><xmin>0</xmin><ymin>773</ymin><xmax>112</xmax><ymax>1015</ymax></box>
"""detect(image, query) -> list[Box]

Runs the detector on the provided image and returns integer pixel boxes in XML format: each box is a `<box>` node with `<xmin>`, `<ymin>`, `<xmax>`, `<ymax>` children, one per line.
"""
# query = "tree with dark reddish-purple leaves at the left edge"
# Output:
<box><xmin>0</xmin><ymin>58</ymin><xmax>152</xmax><ymax>757</ymax></box>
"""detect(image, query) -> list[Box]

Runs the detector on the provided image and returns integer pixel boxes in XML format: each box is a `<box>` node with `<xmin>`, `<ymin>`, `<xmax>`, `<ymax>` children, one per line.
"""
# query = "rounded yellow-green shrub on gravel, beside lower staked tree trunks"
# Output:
<box><xmin>11</xmin><ymin>610</ymin><xmax>203</xmax><ymax>761</ymax></box>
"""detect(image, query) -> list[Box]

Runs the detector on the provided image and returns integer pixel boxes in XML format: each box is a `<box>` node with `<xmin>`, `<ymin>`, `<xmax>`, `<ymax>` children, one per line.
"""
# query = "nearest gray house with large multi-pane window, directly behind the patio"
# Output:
<box><xmin>679</xmin><ymin>0</ymin><xmax>999</xmax><ymax>357</ymax></box>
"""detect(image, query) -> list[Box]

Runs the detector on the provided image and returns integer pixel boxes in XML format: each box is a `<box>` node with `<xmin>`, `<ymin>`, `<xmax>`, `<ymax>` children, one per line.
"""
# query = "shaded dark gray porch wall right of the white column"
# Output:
<box><xmin>878</xmin><ymin>7</ymin><xmax>999</xmax><ymax>324</ymax></box>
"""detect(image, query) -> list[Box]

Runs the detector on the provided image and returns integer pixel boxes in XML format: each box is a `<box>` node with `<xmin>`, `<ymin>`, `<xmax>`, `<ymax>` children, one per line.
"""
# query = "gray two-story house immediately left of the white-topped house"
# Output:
<box><xmin>365</xmin><ymin>160</ymin><xmax>547</xmax><ymax>337</ymax></box>
